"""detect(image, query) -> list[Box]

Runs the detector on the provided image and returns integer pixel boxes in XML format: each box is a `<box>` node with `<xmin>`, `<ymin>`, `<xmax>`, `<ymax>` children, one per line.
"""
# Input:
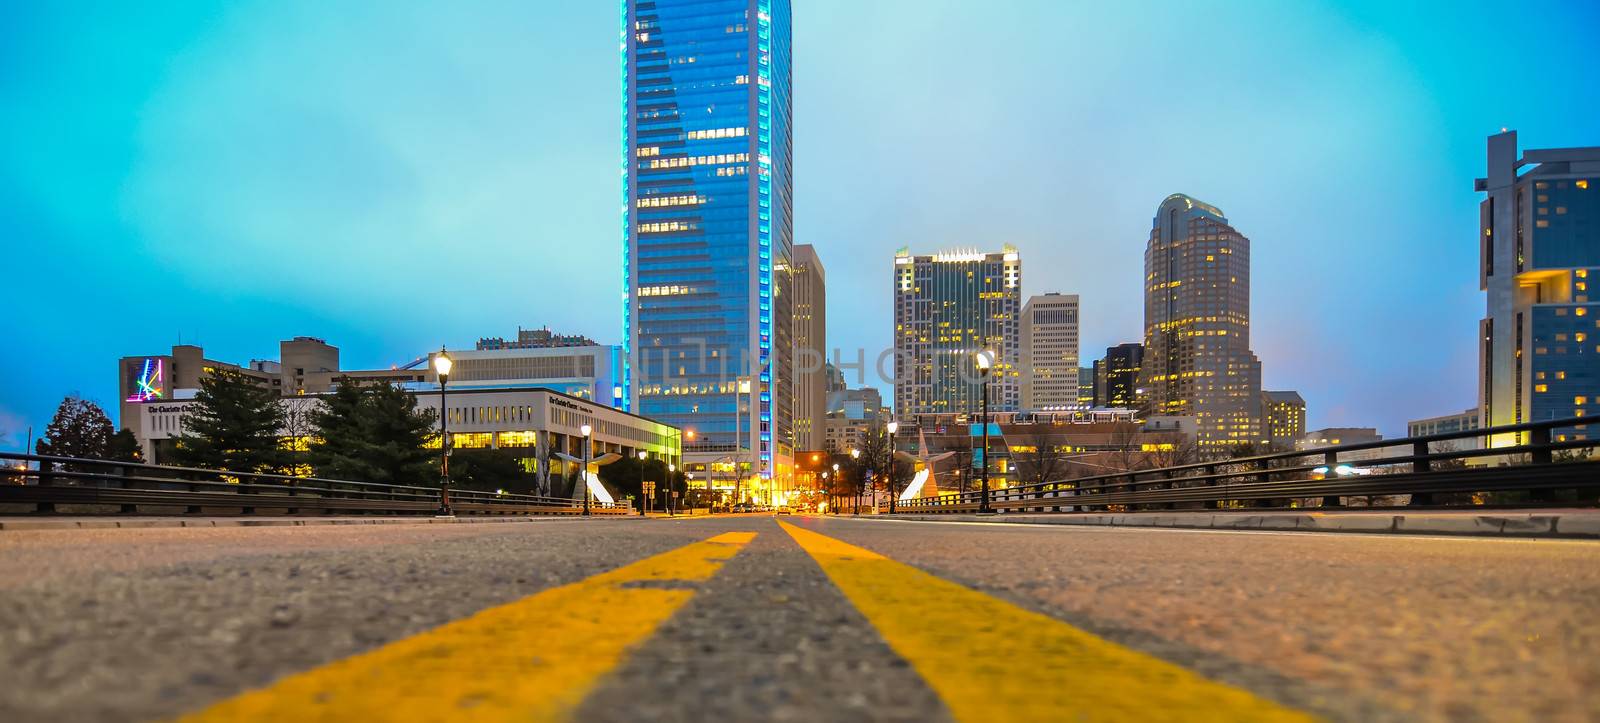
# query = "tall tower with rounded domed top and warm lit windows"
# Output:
<box><xmin>1141</xmin><ymin>194</ymin><xmax>1262</xmax><ymax>448</ymax></box>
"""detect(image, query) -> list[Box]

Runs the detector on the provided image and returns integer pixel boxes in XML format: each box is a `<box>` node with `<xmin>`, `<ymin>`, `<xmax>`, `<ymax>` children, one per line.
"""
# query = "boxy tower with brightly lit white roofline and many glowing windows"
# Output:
<box><xmin>894</xmin><ymin>245</ymin><xmax>1022</xmax><ymax>419</ymax></box>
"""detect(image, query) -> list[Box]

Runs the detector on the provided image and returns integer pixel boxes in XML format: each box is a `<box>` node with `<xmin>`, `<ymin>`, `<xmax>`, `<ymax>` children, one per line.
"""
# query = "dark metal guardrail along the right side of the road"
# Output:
<box><xmin>878</xmin><ymin>417</ymin><xmax>1600</xmax><ymax>513</ymax></box>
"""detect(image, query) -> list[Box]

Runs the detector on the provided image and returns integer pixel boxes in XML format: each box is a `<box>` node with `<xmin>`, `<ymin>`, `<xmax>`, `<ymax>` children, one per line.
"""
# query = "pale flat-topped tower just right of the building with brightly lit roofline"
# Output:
<box><xmin>1021</xmin><ymin>293</ymin><xmax>1078</xmax><ymax>409</ymax></box>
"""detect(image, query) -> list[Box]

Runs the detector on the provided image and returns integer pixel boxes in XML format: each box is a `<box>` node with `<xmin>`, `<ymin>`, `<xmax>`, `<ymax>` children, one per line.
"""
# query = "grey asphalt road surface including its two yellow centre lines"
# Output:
<box><xmin>0</xmin><ymin>517</ymin><xmax>1600</xmax><ymax>721</ymax></box>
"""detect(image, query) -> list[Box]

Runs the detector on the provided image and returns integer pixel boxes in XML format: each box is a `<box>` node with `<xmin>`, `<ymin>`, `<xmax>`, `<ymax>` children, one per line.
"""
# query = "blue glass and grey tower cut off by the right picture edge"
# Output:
<box><xmin>1477</xmin><ymin>131</ymin><xmax>1600</xmax><ymax>446</ymax></box>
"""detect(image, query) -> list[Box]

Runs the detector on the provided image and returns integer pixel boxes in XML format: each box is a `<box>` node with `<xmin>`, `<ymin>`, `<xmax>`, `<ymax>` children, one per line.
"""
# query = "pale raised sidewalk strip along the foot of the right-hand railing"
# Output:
<box><xmin>883</xmin><ymin>509</ymin><xmax>1600</xmax><ymax>539</ymax></box>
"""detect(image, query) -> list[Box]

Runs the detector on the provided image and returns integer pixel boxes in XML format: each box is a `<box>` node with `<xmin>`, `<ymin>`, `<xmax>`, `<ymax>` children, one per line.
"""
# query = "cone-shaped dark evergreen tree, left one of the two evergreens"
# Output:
<box><xmin>173</xmin><ymin>368</ymin><xmax>285</xmax><ymax>472</ymax></box>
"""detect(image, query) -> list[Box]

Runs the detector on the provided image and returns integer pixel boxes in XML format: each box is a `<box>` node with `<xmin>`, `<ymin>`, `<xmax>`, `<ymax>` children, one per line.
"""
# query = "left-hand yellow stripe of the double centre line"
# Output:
<box><xmin>182</xmin><ymin>533</ymin><xmax>755</xmax><ymax>721</ymax></box>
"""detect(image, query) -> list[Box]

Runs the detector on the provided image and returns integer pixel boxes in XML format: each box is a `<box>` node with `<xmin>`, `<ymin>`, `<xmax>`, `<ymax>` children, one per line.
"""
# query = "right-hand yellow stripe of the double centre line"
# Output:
<box><xmin>778</xmin><ymin>521</ymin><xmax>1314</xmax><ymax>721</ymax></box>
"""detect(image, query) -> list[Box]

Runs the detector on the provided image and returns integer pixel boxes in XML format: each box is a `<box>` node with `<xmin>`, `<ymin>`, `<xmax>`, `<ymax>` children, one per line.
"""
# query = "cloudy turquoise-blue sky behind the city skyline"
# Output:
<box><xmin>0</xmin><ymin>0</ymin><xmax>1600</xmax><ymax>446</ymax></box>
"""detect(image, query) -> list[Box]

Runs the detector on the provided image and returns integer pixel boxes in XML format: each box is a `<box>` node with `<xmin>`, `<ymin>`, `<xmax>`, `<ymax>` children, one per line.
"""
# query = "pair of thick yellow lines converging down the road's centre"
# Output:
<box><xmin>186</xmin><ymin>523</ymin><xmax>1310</xmax><ymax>721</ymax></box>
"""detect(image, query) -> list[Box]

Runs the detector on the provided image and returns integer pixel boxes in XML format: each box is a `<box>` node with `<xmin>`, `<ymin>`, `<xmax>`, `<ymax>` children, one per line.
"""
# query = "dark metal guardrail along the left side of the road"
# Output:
<box><xmin>0</xmin><ymin>453</ymin><xmax>630</xmax><ymax>515</ymax></box>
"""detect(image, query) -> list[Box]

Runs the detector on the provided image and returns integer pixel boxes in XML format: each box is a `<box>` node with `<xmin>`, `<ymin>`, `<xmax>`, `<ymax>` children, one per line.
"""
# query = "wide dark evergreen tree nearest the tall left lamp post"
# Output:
<box><xmin>306</xmin><ymin>382</ymin><xmax>440</xmax><ymax>485</ymax></box>
